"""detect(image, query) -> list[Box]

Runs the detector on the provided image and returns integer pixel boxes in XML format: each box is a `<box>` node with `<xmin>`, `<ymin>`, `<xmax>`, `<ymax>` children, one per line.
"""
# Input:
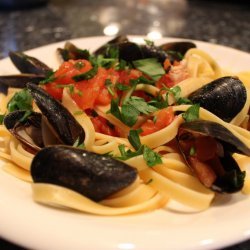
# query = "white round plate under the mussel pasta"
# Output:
<box><xmin>0</xmin><ymin>37</ymin><xmax>250</xmax><ymax>250</ymax></box>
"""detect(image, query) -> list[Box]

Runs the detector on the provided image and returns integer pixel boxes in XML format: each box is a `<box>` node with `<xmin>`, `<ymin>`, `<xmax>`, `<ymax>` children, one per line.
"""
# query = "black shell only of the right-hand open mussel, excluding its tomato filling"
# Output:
<box><xmin>177</xmin><ymin>120</ymin><xmax>250</xmax><ymax>193</ymax></box>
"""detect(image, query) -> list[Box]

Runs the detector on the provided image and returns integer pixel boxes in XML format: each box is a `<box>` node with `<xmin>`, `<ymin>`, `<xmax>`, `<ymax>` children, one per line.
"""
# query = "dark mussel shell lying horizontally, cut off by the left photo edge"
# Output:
<box><xmin>0</xmin><ymin>74</ymin><xmax>45</xmax><ymax>88</ymax></box>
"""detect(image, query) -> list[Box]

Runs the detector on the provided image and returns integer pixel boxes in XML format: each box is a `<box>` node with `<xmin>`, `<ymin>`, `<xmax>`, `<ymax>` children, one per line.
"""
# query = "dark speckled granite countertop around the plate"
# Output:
<box><xmin>0</xmin><ymin>0</ymin><xmax>250</xmax><ymax>250</ymax></box>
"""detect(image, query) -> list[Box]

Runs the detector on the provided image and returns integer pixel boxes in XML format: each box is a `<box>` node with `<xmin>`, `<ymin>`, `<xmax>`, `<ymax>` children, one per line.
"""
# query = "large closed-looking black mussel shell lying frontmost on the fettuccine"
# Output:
<box><xmin>31</xmin><ymin>146</ymin><xmax>137</xmax><ymax>201</ymax></box>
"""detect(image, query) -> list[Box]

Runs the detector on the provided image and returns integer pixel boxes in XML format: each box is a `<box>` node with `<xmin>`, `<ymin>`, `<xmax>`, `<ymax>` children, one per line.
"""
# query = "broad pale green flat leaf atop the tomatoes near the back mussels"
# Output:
<box><xmin>133</xmin><ymin>58</ymin><xmax>165</xmax><ymax>81</ymax></box>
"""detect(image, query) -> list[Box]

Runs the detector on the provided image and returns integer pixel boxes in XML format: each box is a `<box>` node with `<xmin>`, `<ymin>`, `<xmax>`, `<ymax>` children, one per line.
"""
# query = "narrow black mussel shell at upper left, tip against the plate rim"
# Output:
<box><xmin>9</xmin><ymin>51</ymin><xmax>53</xmax><ymax>76</ymax></box>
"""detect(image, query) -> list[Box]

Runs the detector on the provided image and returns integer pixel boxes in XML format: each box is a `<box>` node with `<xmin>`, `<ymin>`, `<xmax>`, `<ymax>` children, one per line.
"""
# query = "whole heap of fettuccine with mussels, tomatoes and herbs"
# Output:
<box><xmin>0</xmin><ymin>36</ymin><xmax>250</xmax><ymax>215</ymax></box>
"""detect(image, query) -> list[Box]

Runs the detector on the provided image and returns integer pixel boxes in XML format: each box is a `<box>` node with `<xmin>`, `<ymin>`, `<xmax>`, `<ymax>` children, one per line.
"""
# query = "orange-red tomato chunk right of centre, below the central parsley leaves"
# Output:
<box><xmin>141</xmin><ymin>108</ymin><xmax>174</xmax><ymax>136</ymax></box>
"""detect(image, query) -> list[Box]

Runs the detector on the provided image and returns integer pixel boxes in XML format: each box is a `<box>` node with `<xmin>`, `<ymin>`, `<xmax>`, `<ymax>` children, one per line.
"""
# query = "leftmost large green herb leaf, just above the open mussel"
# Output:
<box><xmin>7</xmin><ymin>89</ymin><xmax>32</xmax><ymax>112</ymax></box>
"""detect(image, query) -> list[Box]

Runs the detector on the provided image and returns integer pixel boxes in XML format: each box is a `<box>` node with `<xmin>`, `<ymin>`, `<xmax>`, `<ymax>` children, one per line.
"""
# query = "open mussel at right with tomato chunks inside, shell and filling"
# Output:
<box><xmin>177</xmin><ymin>120</ymin><xmax>250</xmax><ymax>193</ymax></box>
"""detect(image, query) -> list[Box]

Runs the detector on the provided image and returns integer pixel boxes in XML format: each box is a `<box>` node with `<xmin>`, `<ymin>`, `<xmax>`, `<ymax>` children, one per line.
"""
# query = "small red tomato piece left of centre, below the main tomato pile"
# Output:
<box><xmin>91</xmin><ymin>116</ymin><xmax>119</xmax><ymax>136</ymax></box>
